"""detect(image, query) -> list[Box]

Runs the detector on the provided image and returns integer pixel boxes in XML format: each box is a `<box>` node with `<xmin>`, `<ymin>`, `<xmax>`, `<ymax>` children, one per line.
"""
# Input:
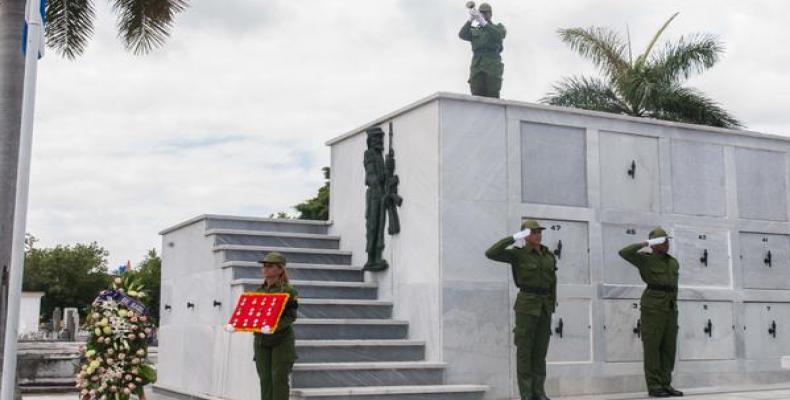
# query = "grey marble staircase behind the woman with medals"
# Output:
<box><xmin>217</xmin><ymin>219</ymin><xmax>487</xmax><ymax>400</ymax></box>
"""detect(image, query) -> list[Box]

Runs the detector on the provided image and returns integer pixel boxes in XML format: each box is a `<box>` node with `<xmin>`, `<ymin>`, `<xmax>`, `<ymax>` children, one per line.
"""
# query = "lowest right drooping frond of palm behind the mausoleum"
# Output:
<box><xmin>650</xmin><ymin>85</ymin><xmax>743</xmax><ymax>128</ymax></box>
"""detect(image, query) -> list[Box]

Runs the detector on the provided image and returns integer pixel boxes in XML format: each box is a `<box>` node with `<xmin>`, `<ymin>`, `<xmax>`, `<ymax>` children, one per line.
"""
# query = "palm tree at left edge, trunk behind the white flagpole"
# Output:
<box><xmin>0</xmin><ymin>0</ymin><xmax>187</xmax><ymax>388</ymax></box>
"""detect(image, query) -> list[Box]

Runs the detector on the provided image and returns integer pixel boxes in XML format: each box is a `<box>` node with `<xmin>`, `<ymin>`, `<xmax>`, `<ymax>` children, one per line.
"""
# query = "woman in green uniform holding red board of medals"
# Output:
<box><xmin>254</xmin><ymin>252</ymin><xmax>299</xmax><ymax>400</ymax></box>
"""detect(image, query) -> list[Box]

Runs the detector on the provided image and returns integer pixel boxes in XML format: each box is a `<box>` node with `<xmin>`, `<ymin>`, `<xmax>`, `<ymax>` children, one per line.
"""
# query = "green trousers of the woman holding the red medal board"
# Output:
<box><xmin>254</xmin><ymin>330</ymin><xmax>296</xmax><ymax>400</ymax></box>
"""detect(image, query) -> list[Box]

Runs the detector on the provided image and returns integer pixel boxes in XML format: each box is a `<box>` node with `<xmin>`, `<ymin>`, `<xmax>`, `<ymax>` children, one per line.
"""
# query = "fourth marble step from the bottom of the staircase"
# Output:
<box><xmin>294</xmin><ymin>318</ymin><xmax>409</xmax><ymax>340</ymax></box>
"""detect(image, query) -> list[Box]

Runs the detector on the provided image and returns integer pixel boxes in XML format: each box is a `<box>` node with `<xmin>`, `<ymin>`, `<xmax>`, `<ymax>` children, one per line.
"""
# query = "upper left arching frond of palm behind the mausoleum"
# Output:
<box><xmin>559</xmin><ymin>27</ymin><xmax>629</xmax><ymax>78</ymax></box>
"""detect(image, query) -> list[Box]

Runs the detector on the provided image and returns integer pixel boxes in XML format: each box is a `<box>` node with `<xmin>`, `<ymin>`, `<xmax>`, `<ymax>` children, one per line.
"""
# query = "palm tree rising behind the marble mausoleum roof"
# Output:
<box><xmin>541</xmin><ymin>13</ymin><xmax>742</xmax><ymax>128</ymax></box>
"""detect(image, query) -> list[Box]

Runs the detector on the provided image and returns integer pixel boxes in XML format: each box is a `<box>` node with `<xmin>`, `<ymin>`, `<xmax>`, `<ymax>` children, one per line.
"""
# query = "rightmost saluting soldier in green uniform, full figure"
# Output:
<box><xmin>620</xmin><ymin>227</ymin><xmax>683</xmax><ymax>397</ymax></box>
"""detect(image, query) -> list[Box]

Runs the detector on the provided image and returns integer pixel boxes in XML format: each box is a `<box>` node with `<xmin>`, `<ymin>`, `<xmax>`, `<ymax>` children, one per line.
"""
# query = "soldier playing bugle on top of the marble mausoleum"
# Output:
<box><xmin>458</xmin><ymin>3</ymin><xmax>507</xmax><ymax>97</ymax></box>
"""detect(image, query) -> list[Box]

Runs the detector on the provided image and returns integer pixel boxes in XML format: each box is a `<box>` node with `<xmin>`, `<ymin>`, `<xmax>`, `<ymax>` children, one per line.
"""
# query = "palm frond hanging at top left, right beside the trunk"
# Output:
<box><xmin>44</xmin><ymin>0</ymin><xmax>96</xmax><ymax>60</ymax></box>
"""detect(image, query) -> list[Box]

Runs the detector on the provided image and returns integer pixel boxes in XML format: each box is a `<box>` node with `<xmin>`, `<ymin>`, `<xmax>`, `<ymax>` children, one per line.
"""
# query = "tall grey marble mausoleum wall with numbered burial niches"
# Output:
<box><xmin>329</xmin><ymin>94</ymin><xmax>790</xmax><ymax>399</ymax></box>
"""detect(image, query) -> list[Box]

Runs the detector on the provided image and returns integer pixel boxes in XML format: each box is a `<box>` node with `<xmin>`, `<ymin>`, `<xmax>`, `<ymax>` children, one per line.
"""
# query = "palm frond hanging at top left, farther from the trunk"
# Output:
<box><xmin>113</xmin><ymin>0</ymin><xmax>187</xmax><ymax>54</ymax></box>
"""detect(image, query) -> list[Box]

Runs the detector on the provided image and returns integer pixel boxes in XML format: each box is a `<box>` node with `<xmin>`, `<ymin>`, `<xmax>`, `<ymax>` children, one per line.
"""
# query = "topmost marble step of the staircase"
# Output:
<box><xmin>204</xmin><ymin>215</ymin><xmax>330</xmax><ymax>235</ymax></box>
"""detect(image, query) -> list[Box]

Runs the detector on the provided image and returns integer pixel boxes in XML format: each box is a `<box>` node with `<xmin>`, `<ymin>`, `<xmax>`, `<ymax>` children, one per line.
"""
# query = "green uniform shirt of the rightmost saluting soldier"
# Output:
<box><xmin>620</xmin><ymin>243</ymin><xmax>680</xmax><ymax>310</ymax></box>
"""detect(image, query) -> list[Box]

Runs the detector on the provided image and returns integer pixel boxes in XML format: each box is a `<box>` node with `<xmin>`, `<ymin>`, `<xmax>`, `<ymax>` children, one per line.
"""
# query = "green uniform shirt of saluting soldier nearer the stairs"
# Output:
<box><xmin>486</xmin><ymin>236</ymin><xmax>557</xmax><ymax>316</ymax></box>
